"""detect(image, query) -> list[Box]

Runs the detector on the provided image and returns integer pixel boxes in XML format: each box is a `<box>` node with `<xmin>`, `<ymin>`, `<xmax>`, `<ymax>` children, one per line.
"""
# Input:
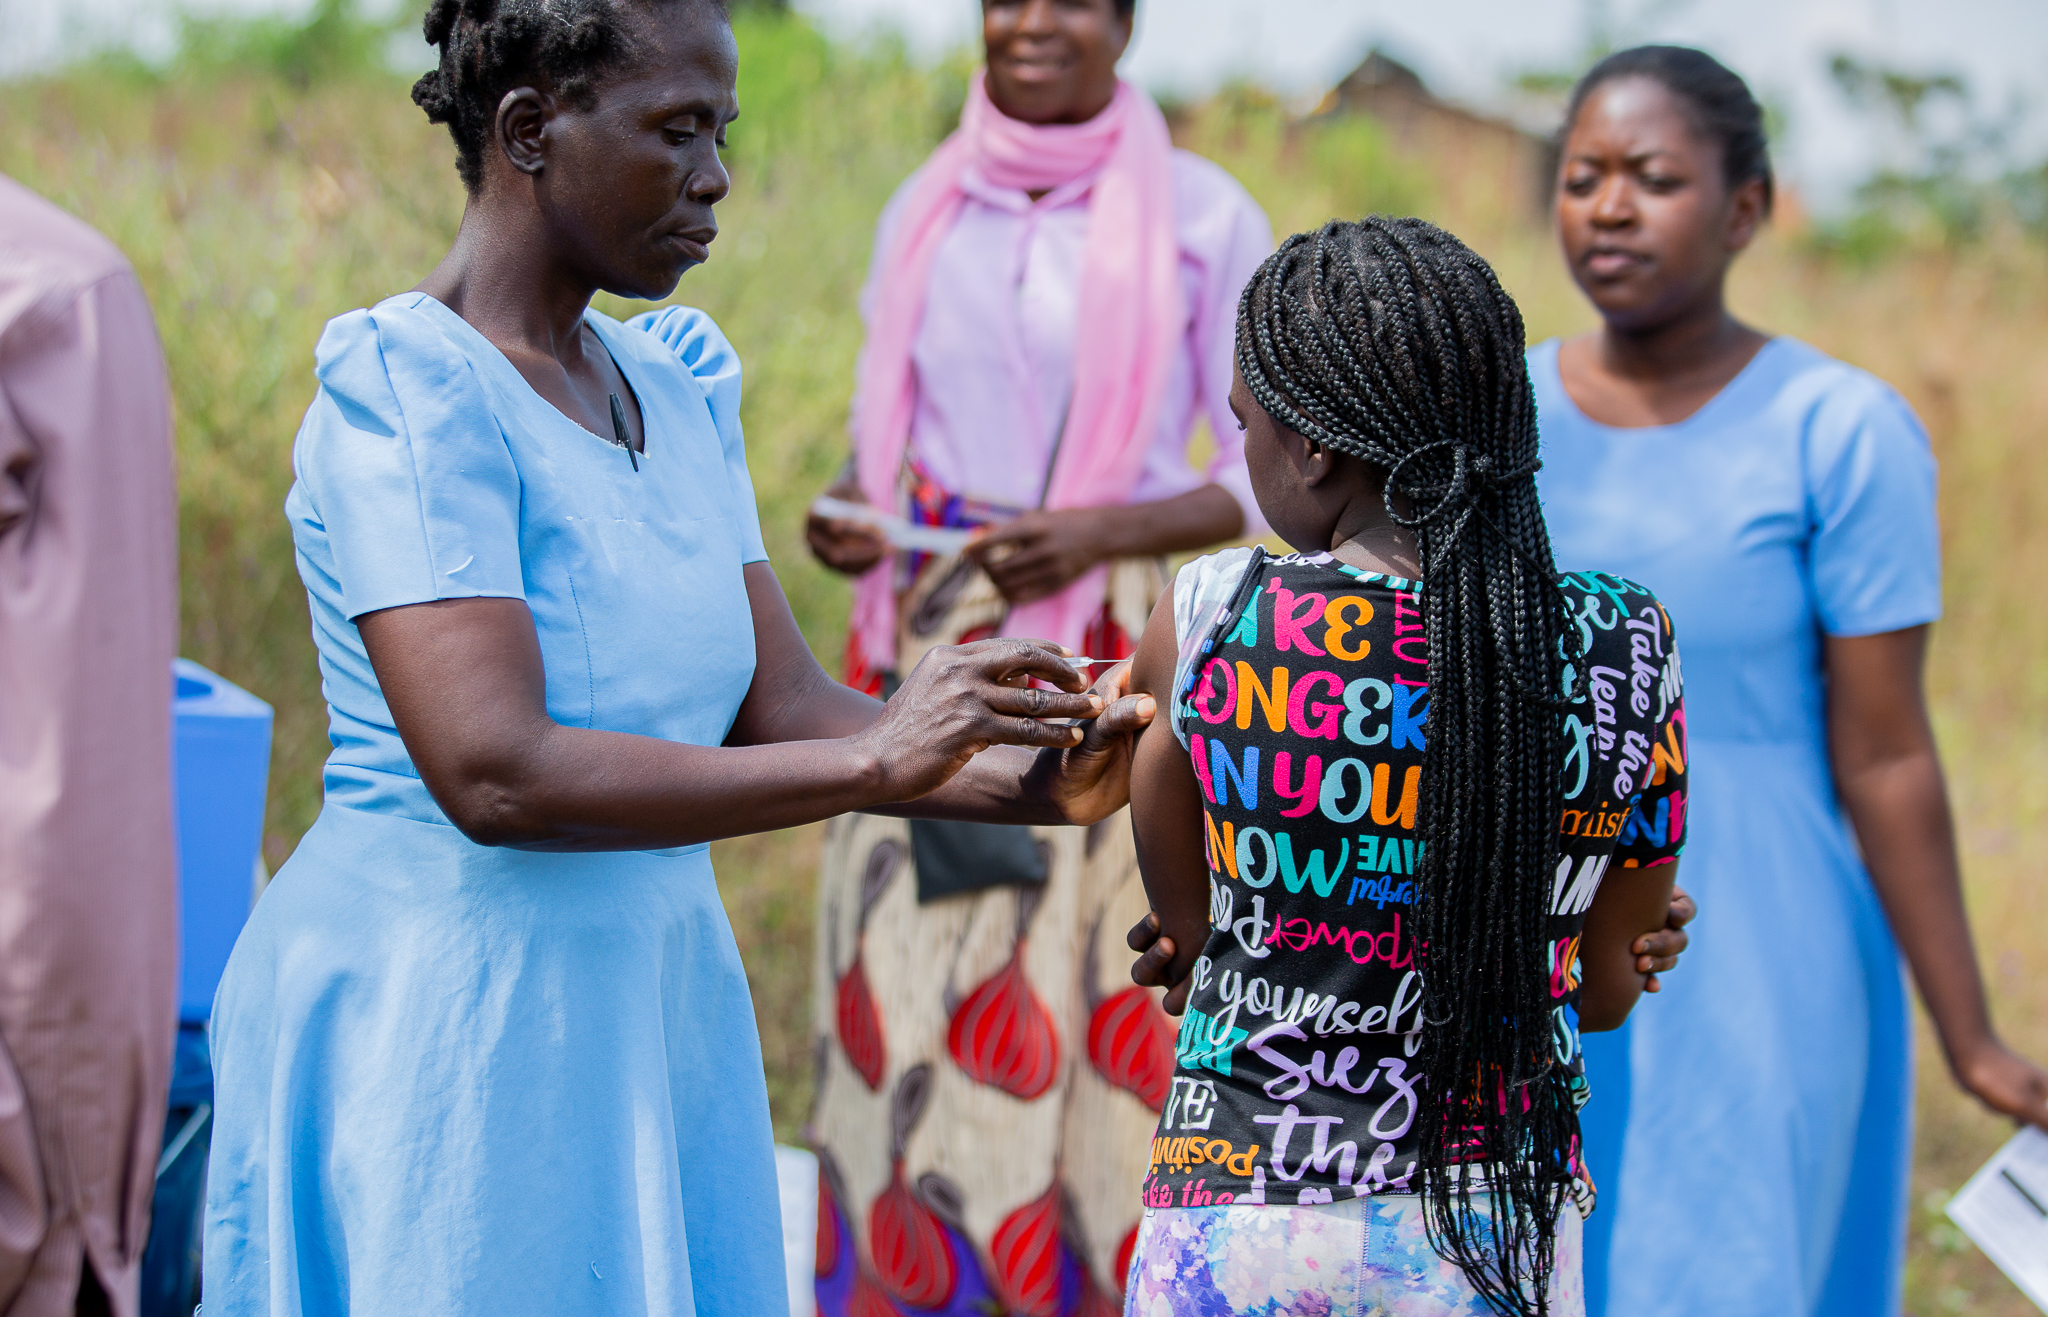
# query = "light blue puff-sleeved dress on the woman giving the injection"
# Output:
<box><xmin>205</xmin><ymin>293</ymin><xmax>786</xmax><ymax>1317</ymax></box>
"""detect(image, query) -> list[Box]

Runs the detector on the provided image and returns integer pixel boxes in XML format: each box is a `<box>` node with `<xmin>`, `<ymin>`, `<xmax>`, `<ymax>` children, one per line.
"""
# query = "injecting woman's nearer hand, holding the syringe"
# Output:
<box><xmin>850</xmin><ymin>639</ymin><xmax>1104</xmax><ymax>803</ymax></box>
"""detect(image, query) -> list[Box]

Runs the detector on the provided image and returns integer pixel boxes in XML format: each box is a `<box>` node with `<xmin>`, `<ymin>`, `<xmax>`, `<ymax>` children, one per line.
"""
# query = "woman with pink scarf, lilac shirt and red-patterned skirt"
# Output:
<box><xmin>809</xmin><ymin>0</ymin><xmax>1272</xmax><ymax>1317</ymax></box>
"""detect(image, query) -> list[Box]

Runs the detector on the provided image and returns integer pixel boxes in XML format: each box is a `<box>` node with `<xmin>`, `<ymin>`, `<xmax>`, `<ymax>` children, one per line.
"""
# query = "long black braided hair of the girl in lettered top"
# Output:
<box><xmin>1237</xmin><ymin>215</ymin><xmax>1585</xmax><ymax>1317</ymax></box>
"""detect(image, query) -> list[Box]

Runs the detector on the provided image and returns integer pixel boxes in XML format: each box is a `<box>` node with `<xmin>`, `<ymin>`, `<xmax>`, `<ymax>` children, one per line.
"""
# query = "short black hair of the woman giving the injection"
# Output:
<box><xmin>412</xmin><ymin>0</ymin><xmax>725</xmax><ymax>193</ymax></box>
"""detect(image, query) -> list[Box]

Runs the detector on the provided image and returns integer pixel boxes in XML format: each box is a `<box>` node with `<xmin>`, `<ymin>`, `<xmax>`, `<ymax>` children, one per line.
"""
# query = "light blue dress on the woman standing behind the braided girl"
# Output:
<box><xmin>1530</xmin><ymin>338</ymin><xmax>1942</xmax><ymax>1317</ymax></box>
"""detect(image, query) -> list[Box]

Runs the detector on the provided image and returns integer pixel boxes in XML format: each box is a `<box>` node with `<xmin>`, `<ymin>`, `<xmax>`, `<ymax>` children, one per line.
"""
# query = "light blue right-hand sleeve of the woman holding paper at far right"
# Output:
<box><xmin>1806</xmin><ymin>371</ymin><xmax>1942</xmax><ymax>637</ymax></box>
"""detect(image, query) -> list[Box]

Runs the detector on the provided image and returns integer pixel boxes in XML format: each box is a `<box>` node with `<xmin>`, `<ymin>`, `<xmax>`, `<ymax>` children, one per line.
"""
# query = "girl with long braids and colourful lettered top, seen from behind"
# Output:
<box><xmin>1126</xmin><ymin>217</ymin><xmax>1686</xmax><ymax>1317</ymax></box>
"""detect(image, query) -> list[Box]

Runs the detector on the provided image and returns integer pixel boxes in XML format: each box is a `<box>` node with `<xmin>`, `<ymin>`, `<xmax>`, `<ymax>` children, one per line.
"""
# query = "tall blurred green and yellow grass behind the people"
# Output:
<box><xmin>0</xmin><ymin>0</ymin><xmax>2048</xmax><ymax>1315</ymax></box>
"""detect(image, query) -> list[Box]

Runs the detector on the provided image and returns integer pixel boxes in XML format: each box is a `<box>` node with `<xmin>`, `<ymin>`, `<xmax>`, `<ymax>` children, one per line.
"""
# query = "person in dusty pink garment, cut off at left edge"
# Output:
<box><xmin>0</xmin><ymin>176</ymin><xmax>178</xmax><ymax>1317</ymax></box>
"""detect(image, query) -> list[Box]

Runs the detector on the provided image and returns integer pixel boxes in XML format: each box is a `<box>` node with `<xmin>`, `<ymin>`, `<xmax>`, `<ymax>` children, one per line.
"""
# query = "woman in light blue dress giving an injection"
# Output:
<box><xmin>205</xmin><ymin>0</ymin><xmax>1149</xmax><ymax>1317</ymax></box>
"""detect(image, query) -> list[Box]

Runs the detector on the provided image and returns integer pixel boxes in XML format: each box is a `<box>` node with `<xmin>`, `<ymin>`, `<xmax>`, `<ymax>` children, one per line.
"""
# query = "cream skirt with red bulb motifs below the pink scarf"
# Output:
<box><xmin>807</xmin><ymin>540</ymin><xmax>1174</xmax><ymax>1317</ymax></box>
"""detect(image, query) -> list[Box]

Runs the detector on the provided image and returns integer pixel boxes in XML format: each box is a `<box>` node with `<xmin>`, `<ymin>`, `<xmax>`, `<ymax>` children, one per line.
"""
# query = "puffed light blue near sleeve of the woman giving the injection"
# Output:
<box><xmin>293</xmin><ymin>305</ymin><xmax>526</xmax><ymax>619</ymax></box>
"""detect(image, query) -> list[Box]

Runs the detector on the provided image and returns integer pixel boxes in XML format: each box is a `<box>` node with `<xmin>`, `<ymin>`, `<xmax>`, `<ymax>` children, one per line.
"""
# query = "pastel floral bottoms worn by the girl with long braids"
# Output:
<box><xmin>1124</xmin><ymin>1194</ymin><xmax>1585</xmax><ymax>1317</ymax></box>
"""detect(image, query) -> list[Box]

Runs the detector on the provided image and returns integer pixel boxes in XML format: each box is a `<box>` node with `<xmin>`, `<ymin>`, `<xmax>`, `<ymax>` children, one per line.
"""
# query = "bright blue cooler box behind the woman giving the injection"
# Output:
<box><xmin>172</xmin><ymin>660</ymin><xmax>270</xmax><ymax>1024</ymax></box>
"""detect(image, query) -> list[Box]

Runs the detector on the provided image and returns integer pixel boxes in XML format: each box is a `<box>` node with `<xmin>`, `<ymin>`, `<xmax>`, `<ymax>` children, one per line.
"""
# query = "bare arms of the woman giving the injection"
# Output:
<box><xmin>356</xmin><ymin>581</ymin><xmax>1114</xmax><ymax>850</ymax></box>
